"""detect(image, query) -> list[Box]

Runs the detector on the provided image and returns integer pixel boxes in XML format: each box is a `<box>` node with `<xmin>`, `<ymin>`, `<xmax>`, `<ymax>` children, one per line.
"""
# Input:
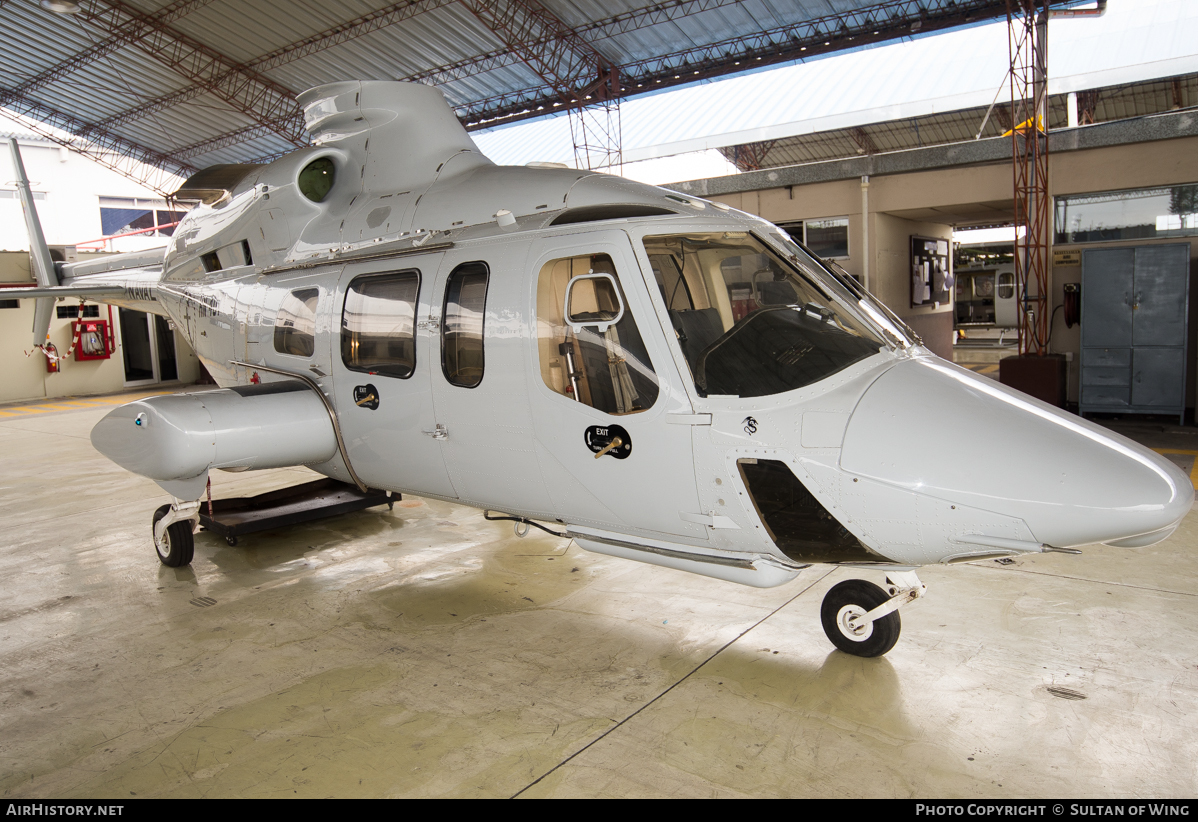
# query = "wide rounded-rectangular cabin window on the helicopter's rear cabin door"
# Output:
<box><xmin>341</xmin><ymin>271</ymin><xmax>420</xmax><ymax>380</ymax></box>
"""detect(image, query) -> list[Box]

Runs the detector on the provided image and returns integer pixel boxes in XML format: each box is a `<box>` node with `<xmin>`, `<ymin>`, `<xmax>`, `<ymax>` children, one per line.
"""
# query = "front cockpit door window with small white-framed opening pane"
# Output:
<box><xmin>537</xmin><ymin>254</ymin><xmax>658</xmax><ymax>415</ymax></box>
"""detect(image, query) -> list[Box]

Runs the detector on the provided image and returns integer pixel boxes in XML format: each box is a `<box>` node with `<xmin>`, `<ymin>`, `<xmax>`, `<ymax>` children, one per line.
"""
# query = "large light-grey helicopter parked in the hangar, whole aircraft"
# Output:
<box><xmin>7</xmin><ymin>81</ymin><xmax>1194</xmax><ymax>657</ymax></box>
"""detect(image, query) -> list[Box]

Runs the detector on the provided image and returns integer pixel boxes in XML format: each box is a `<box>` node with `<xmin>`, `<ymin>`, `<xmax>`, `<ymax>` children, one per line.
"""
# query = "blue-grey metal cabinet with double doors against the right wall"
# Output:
<box><xmin>1079</xmin><ymin>243</ymin><xmax>1190</xmax><ymax>421</ymax></box>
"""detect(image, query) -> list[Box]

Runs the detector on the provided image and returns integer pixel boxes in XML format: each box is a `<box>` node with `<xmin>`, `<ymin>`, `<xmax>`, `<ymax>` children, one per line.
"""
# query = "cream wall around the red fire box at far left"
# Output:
<box><xmin>0</xmin><ymin>252</ymin><xmax>200</xmax><ymax>403</ymax></box>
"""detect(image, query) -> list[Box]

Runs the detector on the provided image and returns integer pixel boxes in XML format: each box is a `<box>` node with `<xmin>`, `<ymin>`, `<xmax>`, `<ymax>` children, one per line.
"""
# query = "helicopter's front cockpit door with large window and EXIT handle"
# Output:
<box><xmin>526</xmin><ymin>231</ymin><xmax>707</xmax><ymax>540</ymax></box>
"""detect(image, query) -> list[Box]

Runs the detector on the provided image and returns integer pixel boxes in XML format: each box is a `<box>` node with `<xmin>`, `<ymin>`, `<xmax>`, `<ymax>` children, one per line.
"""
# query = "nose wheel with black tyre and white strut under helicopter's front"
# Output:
<box><xmin>819</xmin><ymin>570</ymin><xmax>927</xmax><ymax>657</ymax></box>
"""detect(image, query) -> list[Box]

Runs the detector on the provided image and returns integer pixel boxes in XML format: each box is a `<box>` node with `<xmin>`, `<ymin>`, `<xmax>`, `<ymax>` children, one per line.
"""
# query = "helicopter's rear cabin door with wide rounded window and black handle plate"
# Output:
<box><xmin>328</xmin><ymin>254</ymin><xmax>458</xmax><ymax>498</ymax></box>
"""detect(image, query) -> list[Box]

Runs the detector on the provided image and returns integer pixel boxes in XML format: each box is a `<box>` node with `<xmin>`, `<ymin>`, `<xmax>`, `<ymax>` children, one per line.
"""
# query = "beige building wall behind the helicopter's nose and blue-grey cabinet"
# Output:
<box><xmin>712</xmin><ymin>137</ymin><xmax>1198</xmax><ymax>407</ymax></box>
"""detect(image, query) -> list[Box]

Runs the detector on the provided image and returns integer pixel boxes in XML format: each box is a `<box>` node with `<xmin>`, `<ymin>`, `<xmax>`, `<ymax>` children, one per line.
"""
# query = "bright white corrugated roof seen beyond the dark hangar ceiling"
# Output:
<box><xmin>474</xmin><ymin>0</ymin><xmax>1198</xmax><ymax>164</ymax></box>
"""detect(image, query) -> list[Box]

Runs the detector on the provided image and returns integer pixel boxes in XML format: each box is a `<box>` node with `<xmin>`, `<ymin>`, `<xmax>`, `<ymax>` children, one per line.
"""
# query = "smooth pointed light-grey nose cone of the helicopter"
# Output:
<box><xmin>841</xmin><ymin>358</ymin><xmax>1194</xmax><ymax>548</ymax></box>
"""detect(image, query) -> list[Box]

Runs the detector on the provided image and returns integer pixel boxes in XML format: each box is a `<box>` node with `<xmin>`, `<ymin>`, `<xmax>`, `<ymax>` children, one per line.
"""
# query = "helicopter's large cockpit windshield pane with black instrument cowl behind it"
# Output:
<box><xmin>643</xmin><ymin>231</ymin><xmax>885</xmax><ymax>397</ymax></box>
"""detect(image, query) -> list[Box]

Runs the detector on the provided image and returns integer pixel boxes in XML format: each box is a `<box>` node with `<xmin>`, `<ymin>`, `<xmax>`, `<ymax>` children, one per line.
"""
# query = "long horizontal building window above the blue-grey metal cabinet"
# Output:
<box><xmin>1053</xmin><ymin>185</ymin><xmax>1198</xmax><ymax>243</ymax></box>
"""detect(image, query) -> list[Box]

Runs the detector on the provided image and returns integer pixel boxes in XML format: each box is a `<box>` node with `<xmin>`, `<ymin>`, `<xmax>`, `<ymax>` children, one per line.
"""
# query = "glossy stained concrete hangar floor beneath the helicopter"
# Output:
<box><xmin>0</xmin><ymin>395</ymin><xmax>1198</xmax><ymax>798</ymax></box>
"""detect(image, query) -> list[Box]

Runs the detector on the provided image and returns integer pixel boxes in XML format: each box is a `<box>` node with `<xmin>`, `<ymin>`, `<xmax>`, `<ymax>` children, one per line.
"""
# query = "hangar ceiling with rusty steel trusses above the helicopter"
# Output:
<box><xmin>0</xmin><ymin>0</ymin><xmax>1070</xmax><ymax>192</ymax></box>
